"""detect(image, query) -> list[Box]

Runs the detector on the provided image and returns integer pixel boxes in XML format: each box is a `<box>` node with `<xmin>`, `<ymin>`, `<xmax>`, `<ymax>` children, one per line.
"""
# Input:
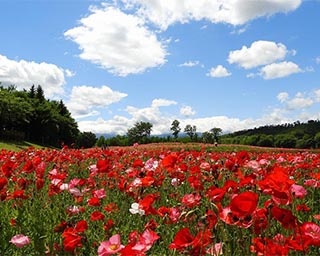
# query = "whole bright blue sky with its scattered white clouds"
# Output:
<box><xmin>0</xmin><ymin>0</ymin><xmax>320</xmax><ymax>135</ymax></box>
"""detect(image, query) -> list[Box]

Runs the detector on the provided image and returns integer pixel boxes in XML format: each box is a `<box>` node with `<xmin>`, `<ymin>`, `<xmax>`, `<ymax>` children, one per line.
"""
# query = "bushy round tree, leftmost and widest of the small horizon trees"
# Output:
<box><xmin>127</xmin><ymin>121</ymin><xmax>153</xmax><ymax>144</ymax></box>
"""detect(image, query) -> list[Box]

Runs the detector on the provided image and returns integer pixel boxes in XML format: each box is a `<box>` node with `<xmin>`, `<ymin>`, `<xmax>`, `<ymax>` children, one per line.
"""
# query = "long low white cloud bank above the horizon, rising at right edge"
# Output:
<box><xmin>78</xmin><ymin>89</ymin><xmax>320</xmax><ymax>135</ymax></box>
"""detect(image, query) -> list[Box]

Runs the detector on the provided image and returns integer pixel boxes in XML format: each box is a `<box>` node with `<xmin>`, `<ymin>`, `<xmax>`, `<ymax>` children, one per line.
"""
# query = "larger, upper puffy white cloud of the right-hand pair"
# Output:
<box><xmin>228</xmin><ymin>41</ymin><xmax>288</xmax><ymax>69</ymax></box>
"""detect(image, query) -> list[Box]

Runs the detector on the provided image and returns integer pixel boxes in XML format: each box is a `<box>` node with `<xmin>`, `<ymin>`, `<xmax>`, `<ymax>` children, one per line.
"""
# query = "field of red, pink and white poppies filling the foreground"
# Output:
<box><xmin>0</xmin><ymin>144</ymin><xmax>320</xmax><ymax>256</ymax></box>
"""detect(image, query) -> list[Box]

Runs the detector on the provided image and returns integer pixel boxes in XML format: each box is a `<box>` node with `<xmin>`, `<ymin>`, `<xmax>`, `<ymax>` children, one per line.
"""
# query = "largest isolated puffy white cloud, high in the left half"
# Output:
<box><xmin>64</xmin><ymin>4</ymin><xmax>167</xmax><ymax>76</ymax></box>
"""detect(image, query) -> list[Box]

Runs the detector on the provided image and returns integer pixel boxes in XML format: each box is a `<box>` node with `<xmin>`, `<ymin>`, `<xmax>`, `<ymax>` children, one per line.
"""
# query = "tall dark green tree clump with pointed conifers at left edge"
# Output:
<box><xmin>0</xmin><ymin>85</ymin><xmax>95</xmax><ymax>147</ymax></box>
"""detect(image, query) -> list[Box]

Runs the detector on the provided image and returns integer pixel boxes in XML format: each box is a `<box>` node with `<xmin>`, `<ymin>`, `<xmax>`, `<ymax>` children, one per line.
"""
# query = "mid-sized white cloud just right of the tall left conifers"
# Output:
<box><xmin>66</xmin><ymin>85</ymin><xmax>127</xmax><ymax>118</ymax></box>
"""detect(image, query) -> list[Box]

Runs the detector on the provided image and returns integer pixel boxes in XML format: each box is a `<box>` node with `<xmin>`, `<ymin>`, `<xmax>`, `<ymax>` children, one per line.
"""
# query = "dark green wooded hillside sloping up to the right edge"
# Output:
<box><xmin>220</xmin><ymin>120</ymin><xmax>320</xmax><ymax>149</ymax></box>
